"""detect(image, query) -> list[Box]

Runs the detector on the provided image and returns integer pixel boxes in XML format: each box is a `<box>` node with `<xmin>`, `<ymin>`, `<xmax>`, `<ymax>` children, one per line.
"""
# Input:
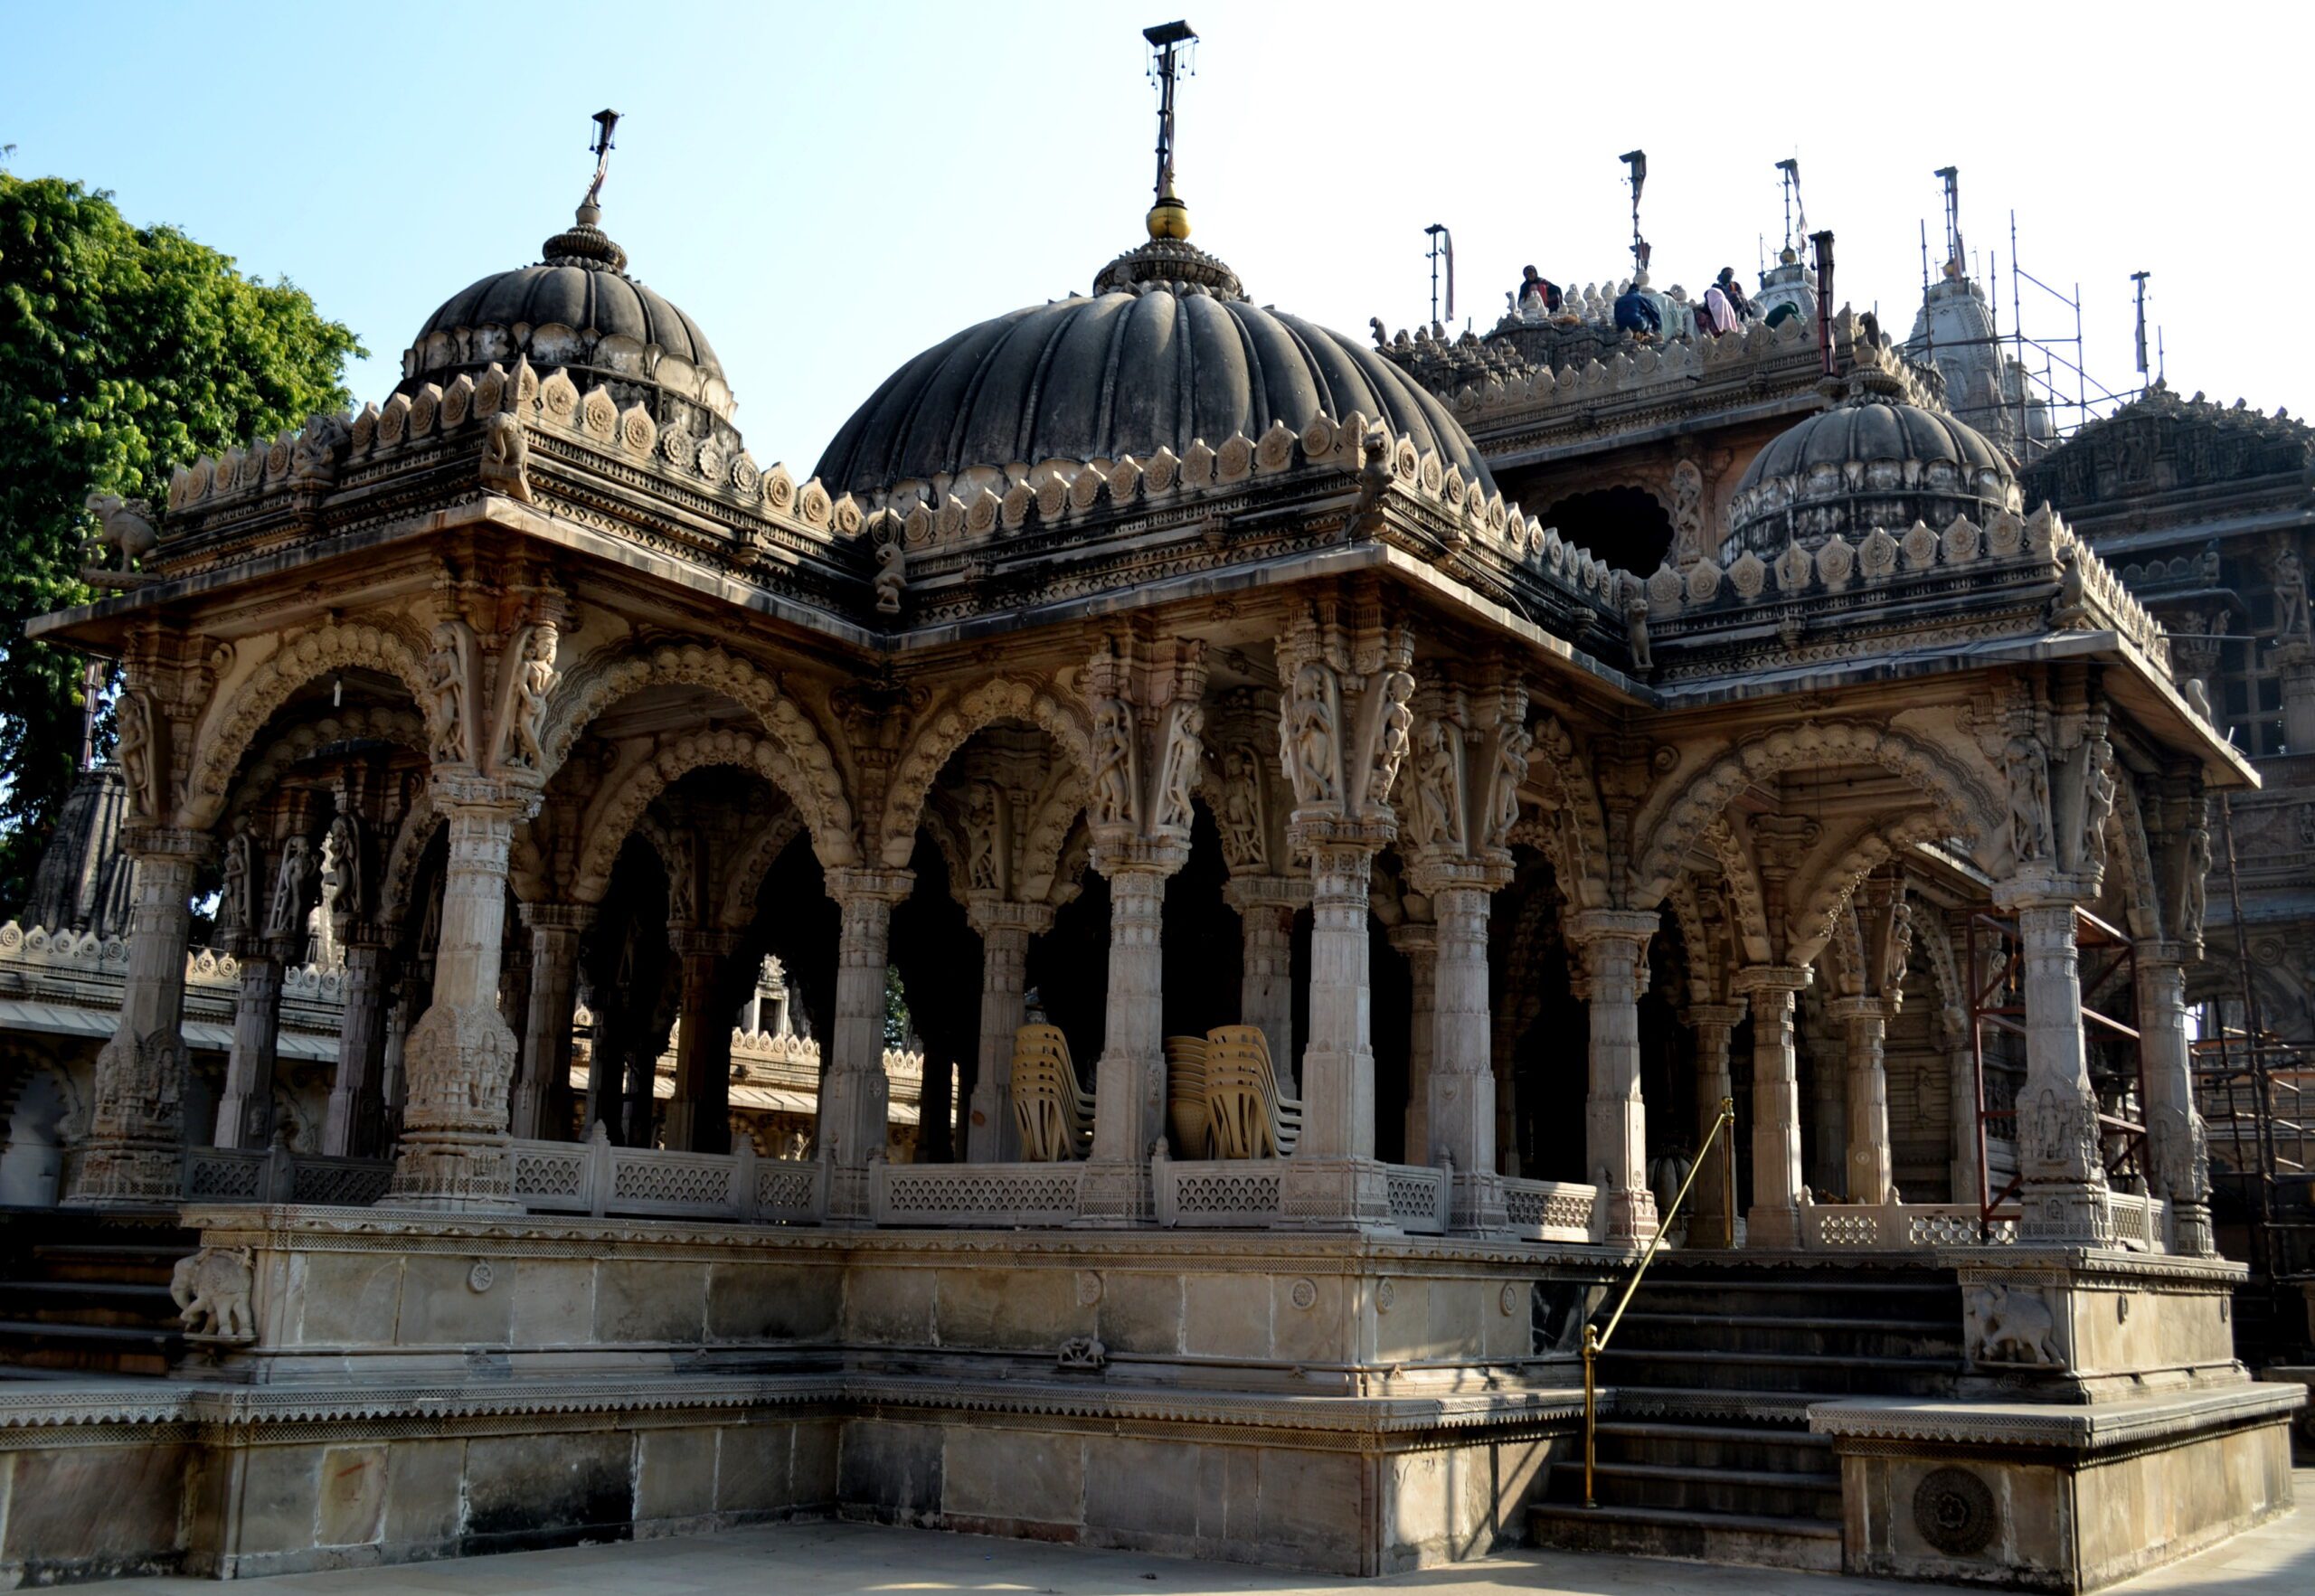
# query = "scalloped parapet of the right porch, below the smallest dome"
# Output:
<box><xmin>1620</xmin><ymin>505</ymin><xmax>2171</xmax><ymax>672</ymax></box>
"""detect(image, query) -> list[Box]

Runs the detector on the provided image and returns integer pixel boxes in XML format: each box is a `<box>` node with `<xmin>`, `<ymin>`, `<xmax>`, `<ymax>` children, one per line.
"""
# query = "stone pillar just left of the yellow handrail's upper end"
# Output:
<box><xmin>1567</xmin><ymin>908</ymin><xmax>1658</xmax><ymax>1246</ymax></box>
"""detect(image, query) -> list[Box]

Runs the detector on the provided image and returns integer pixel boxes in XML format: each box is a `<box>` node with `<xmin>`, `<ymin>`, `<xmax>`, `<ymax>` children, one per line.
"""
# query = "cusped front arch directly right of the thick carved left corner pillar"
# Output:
<box><xmin>539</xmin><ymin>644</ymin><xmax>859</xmax><ymax>869</ymax></box>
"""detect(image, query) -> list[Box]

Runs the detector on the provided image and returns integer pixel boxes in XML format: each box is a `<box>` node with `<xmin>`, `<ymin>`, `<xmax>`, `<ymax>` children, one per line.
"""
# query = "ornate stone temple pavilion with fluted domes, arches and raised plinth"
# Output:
<box><xmin>0</xmin><ymin>59</ymin><xmax>2303</xmax><ymax>1591</ymax></box>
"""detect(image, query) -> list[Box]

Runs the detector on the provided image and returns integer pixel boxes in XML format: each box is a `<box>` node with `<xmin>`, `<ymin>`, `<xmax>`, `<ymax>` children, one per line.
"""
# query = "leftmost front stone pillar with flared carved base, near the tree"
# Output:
<box><xmin>65</xmin><ymin>827</ymin><xmax>211</xmax><ymax>1207</ymax></box>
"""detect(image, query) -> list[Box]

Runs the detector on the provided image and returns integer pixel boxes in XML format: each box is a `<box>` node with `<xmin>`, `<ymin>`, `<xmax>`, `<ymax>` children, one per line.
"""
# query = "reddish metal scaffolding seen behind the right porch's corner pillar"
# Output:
<box><xmin>1968</xmin><ymin>908</ymin><xmax>2149</xmax><ymax>1234</ymax></box>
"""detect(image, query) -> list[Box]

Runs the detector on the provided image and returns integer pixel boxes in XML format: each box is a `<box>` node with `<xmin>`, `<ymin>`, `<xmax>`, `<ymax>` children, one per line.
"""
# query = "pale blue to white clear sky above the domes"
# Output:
<box><xmin>0</xmin><ymin>0</ymin><xmax>2315</xmax><ymax>477</ymax></box>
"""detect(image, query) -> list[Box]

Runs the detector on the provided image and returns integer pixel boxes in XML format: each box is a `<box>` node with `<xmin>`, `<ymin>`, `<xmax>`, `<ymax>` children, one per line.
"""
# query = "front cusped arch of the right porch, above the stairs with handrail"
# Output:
<box><xmin>1632</xmin><ymin>721</ymin><xmax>2002</xmax><ymax>908</ymax></box>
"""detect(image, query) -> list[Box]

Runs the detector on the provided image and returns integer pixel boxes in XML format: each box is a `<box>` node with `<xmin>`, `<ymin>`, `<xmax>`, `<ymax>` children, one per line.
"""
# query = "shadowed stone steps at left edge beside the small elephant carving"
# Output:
<box><xmin>0</xmin><ymin>1207</ymin><xmax>199</xmax><ymax>1378</ymax></box>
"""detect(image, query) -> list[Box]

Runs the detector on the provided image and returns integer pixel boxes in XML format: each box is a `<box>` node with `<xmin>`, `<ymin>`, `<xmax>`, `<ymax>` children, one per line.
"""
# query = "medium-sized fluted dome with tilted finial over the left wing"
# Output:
<box><xmin>402</xmin><ymin>206</ymin><xmax>734</xmax><ymax>421</ymax></box>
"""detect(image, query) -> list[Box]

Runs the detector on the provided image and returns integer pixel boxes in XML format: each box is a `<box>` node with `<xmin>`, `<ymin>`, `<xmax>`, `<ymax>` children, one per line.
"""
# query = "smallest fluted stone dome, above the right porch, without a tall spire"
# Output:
<box><xmin>1727</xmin><ymin>373</ymin><xmax>2018</xmax><ymax>561</ymax></box>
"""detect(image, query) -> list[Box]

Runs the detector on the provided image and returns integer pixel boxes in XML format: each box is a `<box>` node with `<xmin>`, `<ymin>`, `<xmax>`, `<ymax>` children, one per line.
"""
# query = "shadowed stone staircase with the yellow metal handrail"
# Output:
<box><xmin>1528</xmin><ymin>1258</ymin><xmax>1963</xmax><ymax>1571</ymax></box>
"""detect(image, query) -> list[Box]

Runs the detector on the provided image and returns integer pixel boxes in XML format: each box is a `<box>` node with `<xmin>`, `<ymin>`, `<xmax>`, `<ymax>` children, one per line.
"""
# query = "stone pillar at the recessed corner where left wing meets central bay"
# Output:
<box><xmin>819</xmin><ymin>869</ymin><xmax>914</xmax><ymax>1223</ymax></box>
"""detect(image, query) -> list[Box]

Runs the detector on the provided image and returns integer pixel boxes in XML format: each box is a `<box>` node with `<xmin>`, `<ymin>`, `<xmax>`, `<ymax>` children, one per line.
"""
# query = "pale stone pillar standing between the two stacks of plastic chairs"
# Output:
<box><xmin>1083</xmin><ymin>845</ymin><xmax>1167</xmax><ymax>1223</ymax></box>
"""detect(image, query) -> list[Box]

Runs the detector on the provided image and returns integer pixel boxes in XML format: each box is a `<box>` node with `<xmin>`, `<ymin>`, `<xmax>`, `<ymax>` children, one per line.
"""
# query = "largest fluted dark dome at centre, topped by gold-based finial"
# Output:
<box><xmin>817</xmin><ymin>239</ymin><xmax>1493</xmax><ymax>496</ymax></box>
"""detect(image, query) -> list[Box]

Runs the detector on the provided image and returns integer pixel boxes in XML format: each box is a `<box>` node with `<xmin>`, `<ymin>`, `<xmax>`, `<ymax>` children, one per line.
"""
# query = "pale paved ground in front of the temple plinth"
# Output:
<box><xmin>118</xmin><ymin>1469</ymin><xmax>2315</xmax><ymax>1596</ymax></box>
